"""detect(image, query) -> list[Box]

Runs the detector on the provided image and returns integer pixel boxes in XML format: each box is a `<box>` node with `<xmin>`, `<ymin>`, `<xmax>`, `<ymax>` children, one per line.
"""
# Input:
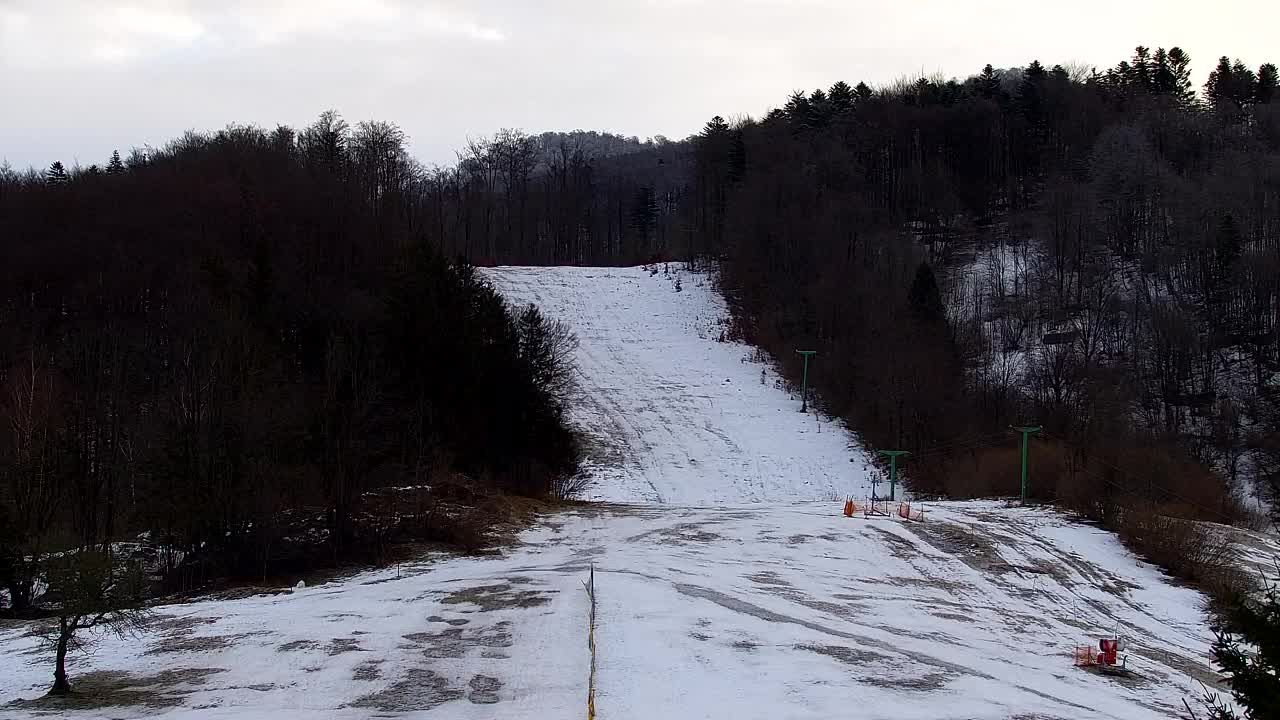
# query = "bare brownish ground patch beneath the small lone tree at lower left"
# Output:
<box><xmin>6</xmin><ymin>667</ymin><xmax>227</xmax><ymax>716</ymax></box>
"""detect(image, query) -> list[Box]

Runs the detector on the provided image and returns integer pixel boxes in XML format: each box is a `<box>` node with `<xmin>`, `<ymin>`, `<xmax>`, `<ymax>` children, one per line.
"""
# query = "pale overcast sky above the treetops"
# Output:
<box><xmin>0</xmin><ymin>0</ymin><xmax>1280</xmax><ymax>167</ymax></box>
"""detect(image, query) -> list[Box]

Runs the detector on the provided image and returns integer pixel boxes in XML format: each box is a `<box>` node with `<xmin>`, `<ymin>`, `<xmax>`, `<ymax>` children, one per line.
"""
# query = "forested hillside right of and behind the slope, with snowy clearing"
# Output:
<box><xmin>340</xmin><ymin>47</ymin><xmax>1280</xmax><ymax>519</ymax></box>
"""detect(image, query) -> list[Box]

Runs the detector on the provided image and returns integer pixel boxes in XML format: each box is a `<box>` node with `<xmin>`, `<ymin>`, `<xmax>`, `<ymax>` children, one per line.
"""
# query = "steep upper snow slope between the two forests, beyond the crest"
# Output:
<box><xmin>485</xmin><ymin>264</ymin><xmax>869</xmax><ymax>505</ymax></box>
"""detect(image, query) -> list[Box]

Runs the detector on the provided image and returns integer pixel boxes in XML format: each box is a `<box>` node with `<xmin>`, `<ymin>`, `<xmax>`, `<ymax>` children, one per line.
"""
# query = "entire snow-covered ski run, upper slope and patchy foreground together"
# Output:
<box><xmin>0</xmin><ymin>268</ymin><xmax>1272</xmax><ymax>720</ymax></box>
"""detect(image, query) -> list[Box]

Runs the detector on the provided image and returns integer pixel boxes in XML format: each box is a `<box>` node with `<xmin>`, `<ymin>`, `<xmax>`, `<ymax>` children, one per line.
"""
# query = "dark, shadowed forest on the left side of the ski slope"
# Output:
<box><xmin>0</xmin><ymin>113</ymin><xmax>576</xmax><ymax>610</ymax></box>
